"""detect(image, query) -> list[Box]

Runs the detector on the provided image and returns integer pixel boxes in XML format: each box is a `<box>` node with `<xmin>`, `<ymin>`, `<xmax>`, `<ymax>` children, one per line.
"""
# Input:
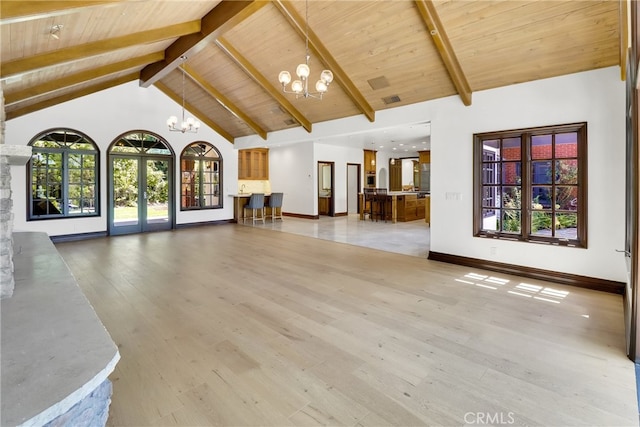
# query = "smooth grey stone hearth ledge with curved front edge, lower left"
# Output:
<box><xmin>0</xmin><ymin>232</ymin><xmax>120</xmax><ymax>426</ymax></box>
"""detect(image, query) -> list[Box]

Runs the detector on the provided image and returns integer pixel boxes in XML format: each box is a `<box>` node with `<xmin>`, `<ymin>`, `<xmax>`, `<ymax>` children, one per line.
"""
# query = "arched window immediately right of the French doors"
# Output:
<box><xmin>180</xmin><ymin>141</ymin><xmax>222</xmax><ymax>210</ymax></box>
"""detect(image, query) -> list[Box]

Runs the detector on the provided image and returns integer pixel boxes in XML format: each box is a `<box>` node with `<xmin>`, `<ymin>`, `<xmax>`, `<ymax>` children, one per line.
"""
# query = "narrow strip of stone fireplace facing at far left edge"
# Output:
<box><xmin>0</xmin><ymin>88</ymin><xmax>15</xmax><ymax>299</ymax></box>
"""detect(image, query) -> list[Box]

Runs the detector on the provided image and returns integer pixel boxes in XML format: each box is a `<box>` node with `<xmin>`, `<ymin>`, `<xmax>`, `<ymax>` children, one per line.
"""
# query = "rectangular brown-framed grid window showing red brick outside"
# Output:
<box><xmin>474</xmin><ymin>123</ymin><xmax>587</xmax><ymax>247</ymax></box>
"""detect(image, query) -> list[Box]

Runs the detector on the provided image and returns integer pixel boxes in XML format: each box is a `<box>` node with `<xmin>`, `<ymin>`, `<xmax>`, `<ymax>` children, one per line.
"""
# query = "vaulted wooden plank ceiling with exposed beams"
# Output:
<box><xmin>0</xmin><ymin>0</ymin><xmax>626</xmax><ymax>142</ymax></box>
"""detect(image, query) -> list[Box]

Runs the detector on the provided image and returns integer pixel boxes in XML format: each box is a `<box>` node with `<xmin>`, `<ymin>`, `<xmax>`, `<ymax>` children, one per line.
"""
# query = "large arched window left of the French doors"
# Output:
<box><xmin>27</xmin><ymin>129</ymin><xmax>100</xmax><ymax>221</ymax></box>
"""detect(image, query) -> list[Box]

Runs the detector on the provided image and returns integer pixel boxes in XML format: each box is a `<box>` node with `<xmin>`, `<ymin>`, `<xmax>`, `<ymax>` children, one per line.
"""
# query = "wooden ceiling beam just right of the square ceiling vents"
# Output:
<box><xmin>415</xmin><ymin>0</ymin><xmax>471</xmax><ymax>106</ymax></box>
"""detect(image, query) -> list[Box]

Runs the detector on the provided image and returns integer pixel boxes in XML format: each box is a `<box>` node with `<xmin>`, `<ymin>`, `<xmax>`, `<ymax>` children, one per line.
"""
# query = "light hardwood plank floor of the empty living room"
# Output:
<box><xmin>56</xmin><ymin>225</ymin><xmax>638</xmax><ymax>426</ymax></box>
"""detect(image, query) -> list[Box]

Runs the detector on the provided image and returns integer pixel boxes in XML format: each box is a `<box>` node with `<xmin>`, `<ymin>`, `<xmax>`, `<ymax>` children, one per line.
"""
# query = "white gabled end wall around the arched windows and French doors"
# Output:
<box><xmin>5</xmin><ymin>82</ymin><xmax>238</xmax><ymax>236</ymax></box>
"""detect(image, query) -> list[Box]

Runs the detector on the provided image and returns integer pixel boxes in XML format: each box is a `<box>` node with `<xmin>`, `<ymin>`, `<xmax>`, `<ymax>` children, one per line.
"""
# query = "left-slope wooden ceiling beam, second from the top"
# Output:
<box><xmin>0</xmin><ymin>21</ymin><xmax>200</xmax><ymax>79</ymax></box>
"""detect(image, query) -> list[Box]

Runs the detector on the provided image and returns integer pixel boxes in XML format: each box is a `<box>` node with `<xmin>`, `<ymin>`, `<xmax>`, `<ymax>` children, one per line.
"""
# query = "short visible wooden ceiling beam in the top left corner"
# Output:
<box><xmin>0</xmin><ymin>0</ymin><xmax>128</xmax><ymax>24</ymax></box>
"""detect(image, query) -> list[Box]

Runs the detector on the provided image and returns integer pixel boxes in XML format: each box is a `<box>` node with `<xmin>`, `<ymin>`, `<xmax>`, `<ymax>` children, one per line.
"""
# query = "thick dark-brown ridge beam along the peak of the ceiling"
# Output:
<box><xmin>140</xmin><ymin>0</ymin><xmax>267</xmax><ymax>87</ymax></box>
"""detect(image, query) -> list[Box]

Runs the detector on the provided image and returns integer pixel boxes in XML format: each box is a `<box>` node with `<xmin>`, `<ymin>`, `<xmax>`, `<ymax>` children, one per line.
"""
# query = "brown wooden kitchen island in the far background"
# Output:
<box><xmin>359</xmin><ymin>191</ymin><xmax>431</xmax><ymax>223</ymax></box>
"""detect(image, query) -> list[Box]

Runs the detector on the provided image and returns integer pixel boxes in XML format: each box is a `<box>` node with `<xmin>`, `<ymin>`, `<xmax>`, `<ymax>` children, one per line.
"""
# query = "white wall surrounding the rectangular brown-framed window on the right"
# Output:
<box><xmin>430</xmin><ymin>67</ymin><xmax>626</xmax><ymax>282</ymax></box>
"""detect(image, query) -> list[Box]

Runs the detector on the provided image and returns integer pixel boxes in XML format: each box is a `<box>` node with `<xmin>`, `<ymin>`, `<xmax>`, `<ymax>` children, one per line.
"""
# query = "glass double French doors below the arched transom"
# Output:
<box><xmin>109</xmin><ymin>155</ymin><xmax>173</xmax><ymax>235</ymax></box>
